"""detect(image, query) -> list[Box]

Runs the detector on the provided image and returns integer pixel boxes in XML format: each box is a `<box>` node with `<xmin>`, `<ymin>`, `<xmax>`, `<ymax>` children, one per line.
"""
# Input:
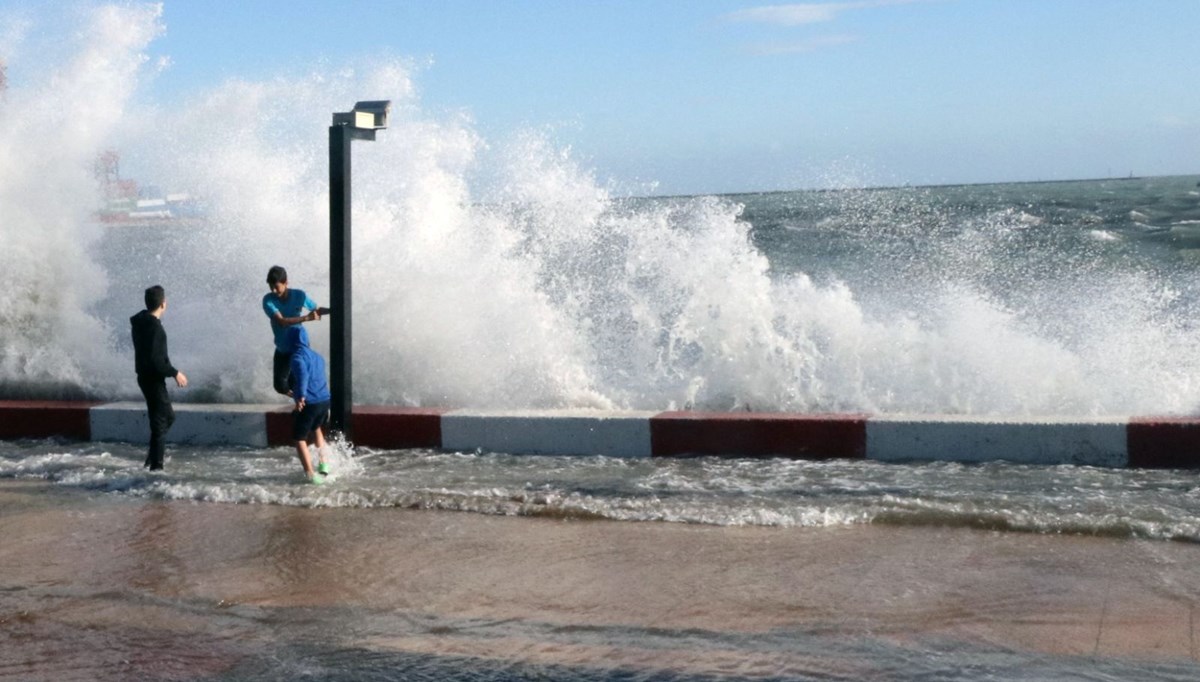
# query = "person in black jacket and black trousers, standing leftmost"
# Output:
<box><xmin>130</xmin><ymin>285</ymin><xmax>187</xmax><ymax>471</ymax></box>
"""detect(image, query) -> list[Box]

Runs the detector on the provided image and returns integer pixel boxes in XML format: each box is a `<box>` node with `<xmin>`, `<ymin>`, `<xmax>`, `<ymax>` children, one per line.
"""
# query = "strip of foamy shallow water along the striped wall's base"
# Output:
<box><xmin>0</xmin><ymin>441</ymin><xmax>1200</xmax><ymax>542</ymax></box>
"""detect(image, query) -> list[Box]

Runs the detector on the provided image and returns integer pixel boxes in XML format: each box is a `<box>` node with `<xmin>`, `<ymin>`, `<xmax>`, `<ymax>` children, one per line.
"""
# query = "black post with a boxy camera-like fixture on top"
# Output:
<box><xmin>329</xmin><ymin>100</ymin><xmax>391</xmax><ymax>439</ymax></box>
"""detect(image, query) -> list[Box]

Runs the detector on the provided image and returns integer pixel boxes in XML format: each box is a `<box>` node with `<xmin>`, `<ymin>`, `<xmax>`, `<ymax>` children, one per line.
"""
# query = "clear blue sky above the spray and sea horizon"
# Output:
<box><xmin>7</xmin><ymin>0</ymin><xmax>1200</xmax><ymax>195</ymax></box>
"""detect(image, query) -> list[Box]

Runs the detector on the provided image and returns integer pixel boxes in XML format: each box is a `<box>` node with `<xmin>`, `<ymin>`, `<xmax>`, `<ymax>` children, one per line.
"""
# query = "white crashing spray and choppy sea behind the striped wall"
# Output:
<box><xmin>0</xmin><ymin>5</ymin><xmax>1200</xmax><ymax>414</ymax></box>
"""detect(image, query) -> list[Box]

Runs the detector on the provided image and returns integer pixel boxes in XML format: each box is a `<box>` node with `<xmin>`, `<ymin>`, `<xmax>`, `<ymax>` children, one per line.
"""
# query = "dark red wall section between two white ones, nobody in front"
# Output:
<box><xmin>650</xmin><ymin>412</ymin><xmax>866</xmax><ymax>460</ymax></box>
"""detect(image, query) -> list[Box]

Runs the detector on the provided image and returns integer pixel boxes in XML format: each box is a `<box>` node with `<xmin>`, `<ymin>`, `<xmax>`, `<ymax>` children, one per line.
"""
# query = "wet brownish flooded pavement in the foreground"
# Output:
<box><xmin>0</xmin><ymin>481</ymin><xmax>1200</xmax><ymax>680</ymax></box>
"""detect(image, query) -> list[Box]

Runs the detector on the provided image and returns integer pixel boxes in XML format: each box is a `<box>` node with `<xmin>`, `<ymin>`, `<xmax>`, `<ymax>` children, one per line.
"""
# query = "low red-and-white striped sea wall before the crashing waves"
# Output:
<box><xmin>0</xmin><ymin>401</ymin><xmax>1200</xmax><ymax>468</ymax></box>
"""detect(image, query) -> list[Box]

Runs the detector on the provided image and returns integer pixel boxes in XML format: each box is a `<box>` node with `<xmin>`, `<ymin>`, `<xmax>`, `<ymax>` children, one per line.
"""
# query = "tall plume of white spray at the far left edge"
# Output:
<box><xmin>0</xmin><ymin>2</ymin><xmax>161</xmax><ymax>393</ymax></box>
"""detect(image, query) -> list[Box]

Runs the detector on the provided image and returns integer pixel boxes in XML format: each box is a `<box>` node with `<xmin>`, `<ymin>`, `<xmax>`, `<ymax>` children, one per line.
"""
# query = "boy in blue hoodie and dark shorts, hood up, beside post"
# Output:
<box><xmin>287</xmin><ymin>325</ymin><xmax>332</xmax><ymax>484</ymax></box>
